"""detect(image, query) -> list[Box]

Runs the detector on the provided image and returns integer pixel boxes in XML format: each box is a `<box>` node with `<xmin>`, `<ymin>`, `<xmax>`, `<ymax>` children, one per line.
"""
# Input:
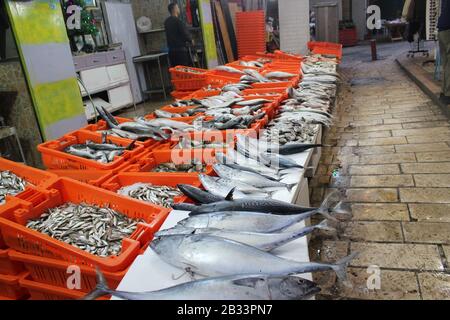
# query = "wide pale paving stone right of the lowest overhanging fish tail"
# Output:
<box><xmin>350</xmin><ymin>242</ymin><xmax>444</xmax><ymax>271</ymax></box>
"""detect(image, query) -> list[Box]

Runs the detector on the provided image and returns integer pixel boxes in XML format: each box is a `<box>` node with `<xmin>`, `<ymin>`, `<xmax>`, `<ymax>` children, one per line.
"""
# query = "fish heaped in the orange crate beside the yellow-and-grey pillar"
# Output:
<box><xmin>64</xmin><ymin>135</ymin><xmax>135</xmax><ymax>163</ymax></box>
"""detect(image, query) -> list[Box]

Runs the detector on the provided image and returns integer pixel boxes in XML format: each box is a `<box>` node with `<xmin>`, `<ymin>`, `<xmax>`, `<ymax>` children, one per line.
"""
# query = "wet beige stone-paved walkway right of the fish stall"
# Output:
<box><xmin>310</xmin><ymin>43</ymin><xmax>450</xmax><ymax>299</ymax></box>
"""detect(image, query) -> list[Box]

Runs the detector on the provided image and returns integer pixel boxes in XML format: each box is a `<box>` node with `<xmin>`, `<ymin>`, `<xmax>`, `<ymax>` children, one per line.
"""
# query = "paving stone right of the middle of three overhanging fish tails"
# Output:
<box><xmin>342</xmin><ymin>221</ymin><xmax>403</xmax><ymax>242</ymax></box>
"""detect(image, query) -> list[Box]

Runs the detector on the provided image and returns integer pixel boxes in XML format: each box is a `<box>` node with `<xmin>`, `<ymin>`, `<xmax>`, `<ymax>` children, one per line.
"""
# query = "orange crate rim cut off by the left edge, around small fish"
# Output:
<box><xmin>0</xmin><ymin>157</ymin><xmax>58</xmax><ymax>195</ymax></box>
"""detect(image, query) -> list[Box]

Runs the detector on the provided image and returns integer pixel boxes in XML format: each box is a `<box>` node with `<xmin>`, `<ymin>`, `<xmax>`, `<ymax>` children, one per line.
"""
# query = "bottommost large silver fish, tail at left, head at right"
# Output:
<box><xmin>84</xmin><ymin>269</ymin><xmax>320</xmax><ymax>300</ymax></box>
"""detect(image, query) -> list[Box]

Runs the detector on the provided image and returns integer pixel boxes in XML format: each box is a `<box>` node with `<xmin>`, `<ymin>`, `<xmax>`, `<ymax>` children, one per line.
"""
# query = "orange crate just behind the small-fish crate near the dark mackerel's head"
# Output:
<box><xmin>138</xmin><ymin>148</ymin><xmax>214</xmax><ymax>178</ymax></box>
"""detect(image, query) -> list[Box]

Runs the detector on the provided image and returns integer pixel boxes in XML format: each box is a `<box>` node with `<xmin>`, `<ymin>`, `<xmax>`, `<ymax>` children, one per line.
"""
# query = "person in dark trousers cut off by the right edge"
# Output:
<box><xmin>438</xmin><ymin>0</ymin><xmax>450</xmax><ymax>104</ymax></box>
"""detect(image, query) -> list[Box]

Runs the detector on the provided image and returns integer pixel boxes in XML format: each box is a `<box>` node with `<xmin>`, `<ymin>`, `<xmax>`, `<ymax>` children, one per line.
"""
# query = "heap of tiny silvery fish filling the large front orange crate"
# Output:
<box><xmin>26</xmin><ymin>203</ymin><xmax>143</xmax><ymax>257</ymax></box>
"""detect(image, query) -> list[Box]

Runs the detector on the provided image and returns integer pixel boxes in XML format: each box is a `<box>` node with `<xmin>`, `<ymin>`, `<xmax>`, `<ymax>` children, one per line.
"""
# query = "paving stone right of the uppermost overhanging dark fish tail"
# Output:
<box><xmin>351</xmin><ymin>203</ymin><xmax>409</xmax><ymax>221</ymax></box>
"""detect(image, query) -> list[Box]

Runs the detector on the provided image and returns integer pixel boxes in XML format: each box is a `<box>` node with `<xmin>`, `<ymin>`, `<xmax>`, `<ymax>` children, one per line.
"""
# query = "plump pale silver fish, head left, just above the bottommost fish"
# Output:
<box><xmin>150</xmin><ymin>234</ymin><xmax>356</xmax><ymax>280</ymax></box>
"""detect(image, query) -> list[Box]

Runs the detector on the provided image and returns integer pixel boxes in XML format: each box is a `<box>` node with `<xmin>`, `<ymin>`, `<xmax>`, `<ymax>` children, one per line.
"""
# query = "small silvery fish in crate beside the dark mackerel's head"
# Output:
<box><xmin>117</xmin><ymin>183</ymin><xmax>183</xmax><ymax>208</ymax></box>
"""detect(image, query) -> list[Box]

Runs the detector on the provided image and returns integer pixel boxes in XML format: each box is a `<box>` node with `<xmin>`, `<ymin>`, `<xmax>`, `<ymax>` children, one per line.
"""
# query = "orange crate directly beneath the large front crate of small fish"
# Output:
<box><xmin>10</xmin><ymin>250</ymin><xmax>128</xmax><ymax>298</ymax></box>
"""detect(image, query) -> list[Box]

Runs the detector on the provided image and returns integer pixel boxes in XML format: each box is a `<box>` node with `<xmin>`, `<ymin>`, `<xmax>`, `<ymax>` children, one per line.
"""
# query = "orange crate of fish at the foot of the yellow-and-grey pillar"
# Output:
<box><xmin>37</xmin><ymin>130</ymin><xmax>144</xmax><ymax>170</ymax></box>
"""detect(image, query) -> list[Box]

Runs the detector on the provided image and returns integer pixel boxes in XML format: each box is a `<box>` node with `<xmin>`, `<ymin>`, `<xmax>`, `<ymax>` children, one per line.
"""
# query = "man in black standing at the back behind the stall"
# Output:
<box><xmin>164</xmin><ymin>3</ymin><xmax>192</xmax><ymax>67</ymax></box>
